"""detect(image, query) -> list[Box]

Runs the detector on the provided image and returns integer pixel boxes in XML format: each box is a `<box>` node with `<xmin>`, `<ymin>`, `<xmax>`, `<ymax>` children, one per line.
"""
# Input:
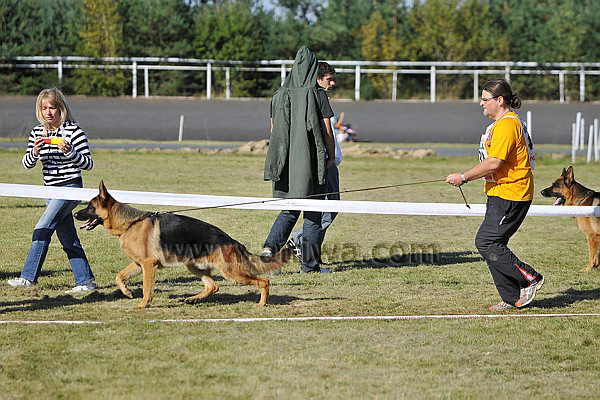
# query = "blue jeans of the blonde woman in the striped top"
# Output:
<box><xmin>21</xmin><ymin>183</ymin><xmax>94</xmax><ymax>285</ymax></box>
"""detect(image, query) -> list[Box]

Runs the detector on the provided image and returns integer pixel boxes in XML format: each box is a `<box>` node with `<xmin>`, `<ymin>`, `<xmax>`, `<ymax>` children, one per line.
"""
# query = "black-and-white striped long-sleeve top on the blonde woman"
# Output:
<box><xmin>23</xmin><ymin>121</ymin><xmax>94</xmax><ymax>186</ymax></box>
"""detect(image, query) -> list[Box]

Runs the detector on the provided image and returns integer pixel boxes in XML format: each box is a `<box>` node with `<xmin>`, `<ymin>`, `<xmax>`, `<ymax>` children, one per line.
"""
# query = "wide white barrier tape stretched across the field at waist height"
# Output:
<box><xmin>0</xmin><ymin>183</ymin><xmax>600</xmax><ymax>217</ymax></box>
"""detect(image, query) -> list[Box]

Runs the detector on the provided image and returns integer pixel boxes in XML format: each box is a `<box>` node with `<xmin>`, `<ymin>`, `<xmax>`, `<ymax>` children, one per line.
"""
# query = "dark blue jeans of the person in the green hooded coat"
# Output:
<box><xmin>264</xmin><ymin>210</ymin><xmax>321</xmax><ymax>272</ymax></box>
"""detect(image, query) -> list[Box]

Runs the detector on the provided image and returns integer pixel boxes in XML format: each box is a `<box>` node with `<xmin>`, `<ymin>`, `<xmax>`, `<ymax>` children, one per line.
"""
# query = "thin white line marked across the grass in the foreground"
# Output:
<box><xmin>0</xmin><ymin>314</ymin><xmax>600</xmax><ymax>325</ymax></box>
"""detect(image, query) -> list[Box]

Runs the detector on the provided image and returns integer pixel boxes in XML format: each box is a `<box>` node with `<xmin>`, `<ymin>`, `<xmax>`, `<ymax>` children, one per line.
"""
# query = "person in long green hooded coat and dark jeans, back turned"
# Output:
<box><xmin>260</xmin><ymin>46</ymin><xmax>335</xmax><ymax>272</ymax></box>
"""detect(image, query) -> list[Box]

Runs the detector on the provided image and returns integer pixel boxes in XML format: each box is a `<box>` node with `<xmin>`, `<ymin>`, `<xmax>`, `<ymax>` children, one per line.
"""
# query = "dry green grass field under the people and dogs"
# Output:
<box><xmin>0</xmin><ymin>151</ymin><xmax>600</xmax><ymax>399</ymax></box>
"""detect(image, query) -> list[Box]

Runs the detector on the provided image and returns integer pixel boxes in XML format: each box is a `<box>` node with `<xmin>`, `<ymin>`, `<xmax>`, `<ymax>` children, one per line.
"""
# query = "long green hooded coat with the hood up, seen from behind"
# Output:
<box><xmin>264</xmin><ymin>46</ymin><xmax>327</xmax><ymax>198</ymax></box>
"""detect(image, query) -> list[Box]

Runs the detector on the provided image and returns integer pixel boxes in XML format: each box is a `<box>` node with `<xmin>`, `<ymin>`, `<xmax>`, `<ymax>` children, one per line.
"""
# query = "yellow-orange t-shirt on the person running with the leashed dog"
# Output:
<box><xmin>482</xmin><ymin>111</ymin><xmax>534</xmax><ymax>201</ymax></box>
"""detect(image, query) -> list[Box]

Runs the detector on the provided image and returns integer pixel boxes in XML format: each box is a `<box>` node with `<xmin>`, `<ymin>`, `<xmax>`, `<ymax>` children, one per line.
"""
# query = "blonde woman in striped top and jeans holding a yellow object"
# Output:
<box><xmin>8</xmin><ymin>88</ymin><xmax>96</xmax><ymax>293</ymax></box>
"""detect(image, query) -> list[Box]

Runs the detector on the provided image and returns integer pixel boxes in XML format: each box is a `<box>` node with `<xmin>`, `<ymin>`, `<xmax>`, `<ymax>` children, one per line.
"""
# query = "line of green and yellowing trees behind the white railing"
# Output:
<box><xmin>0</xmin><ymin>0</ymin><xmax>600</xmax><ymax>99</ymax></box>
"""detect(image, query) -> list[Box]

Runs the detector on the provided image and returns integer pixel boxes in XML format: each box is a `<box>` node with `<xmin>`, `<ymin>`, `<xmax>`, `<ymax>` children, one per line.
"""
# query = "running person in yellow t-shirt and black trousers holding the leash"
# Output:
<box><xmin>446</xmin><ymin>79</ymin><xmax>544</xmax><ymax>311</ymax></box>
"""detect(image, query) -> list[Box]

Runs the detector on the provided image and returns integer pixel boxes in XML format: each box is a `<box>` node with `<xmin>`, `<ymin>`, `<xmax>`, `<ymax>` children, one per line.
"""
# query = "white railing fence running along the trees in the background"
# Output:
<box><xmin>0</xmin><ymin>56</ymin><xmax>600</xmax><ymax>103</ymax></box>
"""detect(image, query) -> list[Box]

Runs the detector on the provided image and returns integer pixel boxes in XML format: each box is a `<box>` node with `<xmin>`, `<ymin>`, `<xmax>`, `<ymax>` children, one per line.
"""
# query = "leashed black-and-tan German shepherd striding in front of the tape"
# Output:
<box><xmin>75</xmin><ymin>181</ymin><xmax>292</xmax><ymax>308</ymax></box>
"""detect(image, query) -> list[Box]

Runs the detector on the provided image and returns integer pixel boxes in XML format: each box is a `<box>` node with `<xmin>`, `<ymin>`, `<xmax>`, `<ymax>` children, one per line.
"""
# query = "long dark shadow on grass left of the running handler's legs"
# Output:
<box><xmin>329</xmin><ymin>251</ymin><xmax>483</xmax><ymax>271</ymax></box>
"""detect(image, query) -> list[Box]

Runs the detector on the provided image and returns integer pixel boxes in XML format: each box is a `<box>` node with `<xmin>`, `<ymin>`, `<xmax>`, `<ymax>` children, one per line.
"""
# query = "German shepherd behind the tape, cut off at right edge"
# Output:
<box><xmin>542</xmin><ymin>167</ymin><xmax>600</xmax><ymax>271</ymax></box>
